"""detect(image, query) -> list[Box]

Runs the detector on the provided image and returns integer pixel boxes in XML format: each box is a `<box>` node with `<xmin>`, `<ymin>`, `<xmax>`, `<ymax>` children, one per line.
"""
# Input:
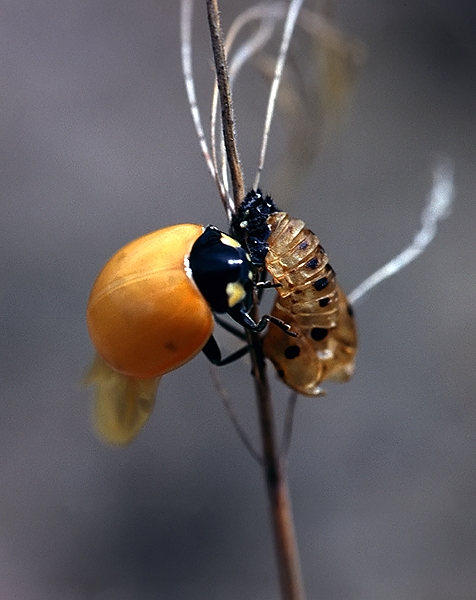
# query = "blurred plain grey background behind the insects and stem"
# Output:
<box><xmin>0</xmin><ymin>0</ymin><xmax>476</xmax><ymax>600</ymax></box>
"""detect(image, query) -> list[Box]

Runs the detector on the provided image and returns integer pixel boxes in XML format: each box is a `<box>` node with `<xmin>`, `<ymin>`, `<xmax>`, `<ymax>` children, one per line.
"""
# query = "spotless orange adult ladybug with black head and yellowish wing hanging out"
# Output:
<box><xmin>87</xmin><ymin>224</ymin><xmax>289</xmax><ymax>444</ymax></box>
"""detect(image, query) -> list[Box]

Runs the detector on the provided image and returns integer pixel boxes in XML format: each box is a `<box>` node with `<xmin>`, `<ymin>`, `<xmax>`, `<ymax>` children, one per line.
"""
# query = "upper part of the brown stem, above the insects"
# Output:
<box><xmin>207</xmin><ymin>0</ymin><xmax>245</xmax><ymax>207</ymax></box>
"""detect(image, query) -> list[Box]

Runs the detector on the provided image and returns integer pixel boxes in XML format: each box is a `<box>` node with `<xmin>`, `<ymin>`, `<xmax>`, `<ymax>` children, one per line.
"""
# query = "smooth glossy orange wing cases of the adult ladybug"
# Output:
<box><xmin>87</xmin><ymin>224</ymin><xmax>213</xmax><ymax>379</ymax></box>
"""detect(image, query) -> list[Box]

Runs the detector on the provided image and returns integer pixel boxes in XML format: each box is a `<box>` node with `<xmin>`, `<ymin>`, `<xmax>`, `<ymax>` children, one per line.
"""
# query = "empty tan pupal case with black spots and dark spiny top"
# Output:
<box><xmin>232</xmin><ymin>190</ymin><xmax>357</xmax><ymax>396</ymax></box>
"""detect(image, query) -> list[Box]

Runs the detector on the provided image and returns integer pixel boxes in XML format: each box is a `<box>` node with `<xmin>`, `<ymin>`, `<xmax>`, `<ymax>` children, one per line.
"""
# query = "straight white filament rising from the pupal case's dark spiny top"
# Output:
<box><xmin>253</xmin><ymin>0</ymin><xmax>303</xmax><ymax>190</ymax></box>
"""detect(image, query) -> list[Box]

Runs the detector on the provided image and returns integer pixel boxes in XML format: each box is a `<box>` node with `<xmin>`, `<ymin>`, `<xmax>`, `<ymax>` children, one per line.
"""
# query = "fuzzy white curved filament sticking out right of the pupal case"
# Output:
<box><xmin>348</xmin><ymin>159</ymin><xmax>455</xmax><ymax>304</ymax></box>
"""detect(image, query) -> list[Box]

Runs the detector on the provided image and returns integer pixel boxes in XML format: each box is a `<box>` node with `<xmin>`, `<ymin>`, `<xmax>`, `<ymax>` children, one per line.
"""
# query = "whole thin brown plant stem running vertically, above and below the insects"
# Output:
<box><xmin>207</xmin><ymin>0</ymin><xmax>304</xmax><ymax>600</ymax></box>
